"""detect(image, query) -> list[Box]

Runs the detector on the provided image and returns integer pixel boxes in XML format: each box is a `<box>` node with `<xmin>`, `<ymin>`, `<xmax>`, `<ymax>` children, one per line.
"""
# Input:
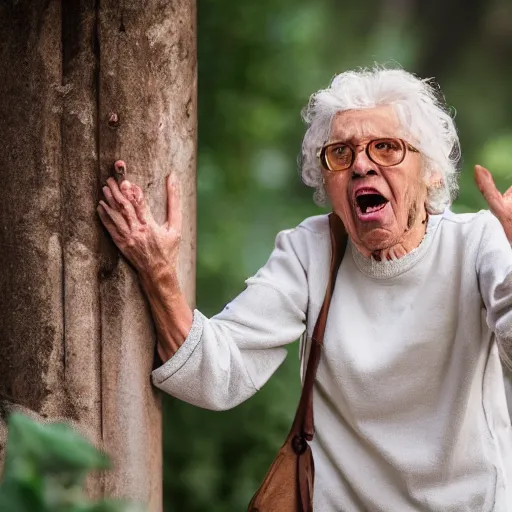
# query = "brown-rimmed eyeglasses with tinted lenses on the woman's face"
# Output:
<box><xmin>318</xmin><ymin>139</ymin><xmax>419</xmax><ymax>171</ymax></box>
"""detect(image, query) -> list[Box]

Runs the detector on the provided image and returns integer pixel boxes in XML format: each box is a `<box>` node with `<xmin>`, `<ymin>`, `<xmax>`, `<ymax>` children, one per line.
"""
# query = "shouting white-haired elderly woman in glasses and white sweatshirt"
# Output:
<box><xmin>98</xmin><ymin>68</ymin><xmax>512</xmax><ymax>512</ymax></box>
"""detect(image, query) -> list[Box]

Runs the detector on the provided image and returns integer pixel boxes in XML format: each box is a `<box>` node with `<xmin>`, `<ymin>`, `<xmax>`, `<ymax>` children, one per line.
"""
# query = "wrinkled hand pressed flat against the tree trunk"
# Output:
<box><xmin>98</xmin><ymin>160</ymin><xmax>182</xmax><ymax>278</ymax></box>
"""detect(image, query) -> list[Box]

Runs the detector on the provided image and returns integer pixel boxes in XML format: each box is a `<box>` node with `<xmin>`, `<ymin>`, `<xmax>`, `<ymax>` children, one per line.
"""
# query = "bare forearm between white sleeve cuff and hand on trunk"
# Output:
<box><xmin>140</xmin><ymin>266</ymin><xmax>193</xmax><ymax>362</ymax></box>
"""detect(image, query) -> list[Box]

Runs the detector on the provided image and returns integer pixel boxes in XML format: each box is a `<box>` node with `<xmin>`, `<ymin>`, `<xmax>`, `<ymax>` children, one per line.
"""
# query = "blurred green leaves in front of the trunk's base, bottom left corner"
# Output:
<box><xmin>0</xmin><ymin>414</ymin><xmax>140</xmax><ymax>512</ymax></box>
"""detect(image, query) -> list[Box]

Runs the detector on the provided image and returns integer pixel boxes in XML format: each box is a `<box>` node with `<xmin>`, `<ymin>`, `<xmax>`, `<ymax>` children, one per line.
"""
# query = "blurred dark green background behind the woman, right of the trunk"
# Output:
<box><xmin>164</xmin><ymin>0</ymin><xmax>512</xmax><ymax>512</ymax></box>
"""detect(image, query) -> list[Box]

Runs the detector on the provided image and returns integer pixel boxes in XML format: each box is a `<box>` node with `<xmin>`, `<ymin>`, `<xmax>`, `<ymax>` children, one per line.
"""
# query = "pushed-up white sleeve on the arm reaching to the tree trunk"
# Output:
<box><xmin>152</xmin><ymin>228</ymin><xmax>308</xmax><ymax>410</ymax></box>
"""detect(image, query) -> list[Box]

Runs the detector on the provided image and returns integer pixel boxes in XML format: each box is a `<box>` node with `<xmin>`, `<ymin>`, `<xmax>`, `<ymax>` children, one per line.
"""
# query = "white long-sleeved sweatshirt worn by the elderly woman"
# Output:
<box><xmin>153</xmin><ymin>210</ymin><xmax>512</xmax><ymax>512</ymax></box>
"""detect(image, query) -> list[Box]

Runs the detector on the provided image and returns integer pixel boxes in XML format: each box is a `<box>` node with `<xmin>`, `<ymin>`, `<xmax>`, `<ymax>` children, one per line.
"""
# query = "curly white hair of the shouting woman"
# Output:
<box><xmin>299</xmin><ymin>66</ymin><xmax>460</xmax><ymax>213</ymax></box>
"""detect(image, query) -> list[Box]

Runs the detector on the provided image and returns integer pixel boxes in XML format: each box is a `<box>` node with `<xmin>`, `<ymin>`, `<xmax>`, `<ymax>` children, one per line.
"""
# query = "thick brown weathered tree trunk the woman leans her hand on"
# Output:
<box><xmin>0</xmin><ymin>0</ymin><xmax>196</xmax><ymax>511</ymax></box>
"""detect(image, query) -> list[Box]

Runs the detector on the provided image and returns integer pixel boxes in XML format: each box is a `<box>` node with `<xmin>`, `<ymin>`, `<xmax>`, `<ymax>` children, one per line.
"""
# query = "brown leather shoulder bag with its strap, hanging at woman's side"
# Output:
<box><xmin>248</xmin><ymin>213</ymin><xmax>347</xmax><ymax>512</ymax></box>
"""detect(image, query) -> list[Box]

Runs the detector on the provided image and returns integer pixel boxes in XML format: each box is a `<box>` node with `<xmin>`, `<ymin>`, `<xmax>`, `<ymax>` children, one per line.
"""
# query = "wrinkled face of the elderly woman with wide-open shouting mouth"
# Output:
<box><xmin>323</xmin><ymin>106</ymin><xmax>427</xmax><ymax>254</ymax></box>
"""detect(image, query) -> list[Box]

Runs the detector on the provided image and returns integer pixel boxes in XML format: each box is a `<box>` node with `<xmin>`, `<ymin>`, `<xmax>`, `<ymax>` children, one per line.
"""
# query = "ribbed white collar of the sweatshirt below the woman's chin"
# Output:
<box><xmin>349</xmin><ymin>214</ymin><xmax>443</xmax><ymax>279</ymax></box>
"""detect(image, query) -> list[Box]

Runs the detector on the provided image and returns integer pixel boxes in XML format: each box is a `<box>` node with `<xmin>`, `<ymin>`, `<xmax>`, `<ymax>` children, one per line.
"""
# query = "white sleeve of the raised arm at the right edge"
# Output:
<box><xmin>477</xmin><ymin>213</ymin><xmax>512</xmax><ymax>367</ymax></box>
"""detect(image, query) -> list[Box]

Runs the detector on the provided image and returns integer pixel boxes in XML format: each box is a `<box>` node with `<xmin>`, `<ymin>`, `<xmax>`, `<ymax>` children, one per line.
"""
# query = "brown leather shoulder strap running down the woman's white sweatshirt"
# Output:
<box><xmin>292</xmin><ymin>213</ymin><xmax>348</xmax><ymax>441</ymax></box>
